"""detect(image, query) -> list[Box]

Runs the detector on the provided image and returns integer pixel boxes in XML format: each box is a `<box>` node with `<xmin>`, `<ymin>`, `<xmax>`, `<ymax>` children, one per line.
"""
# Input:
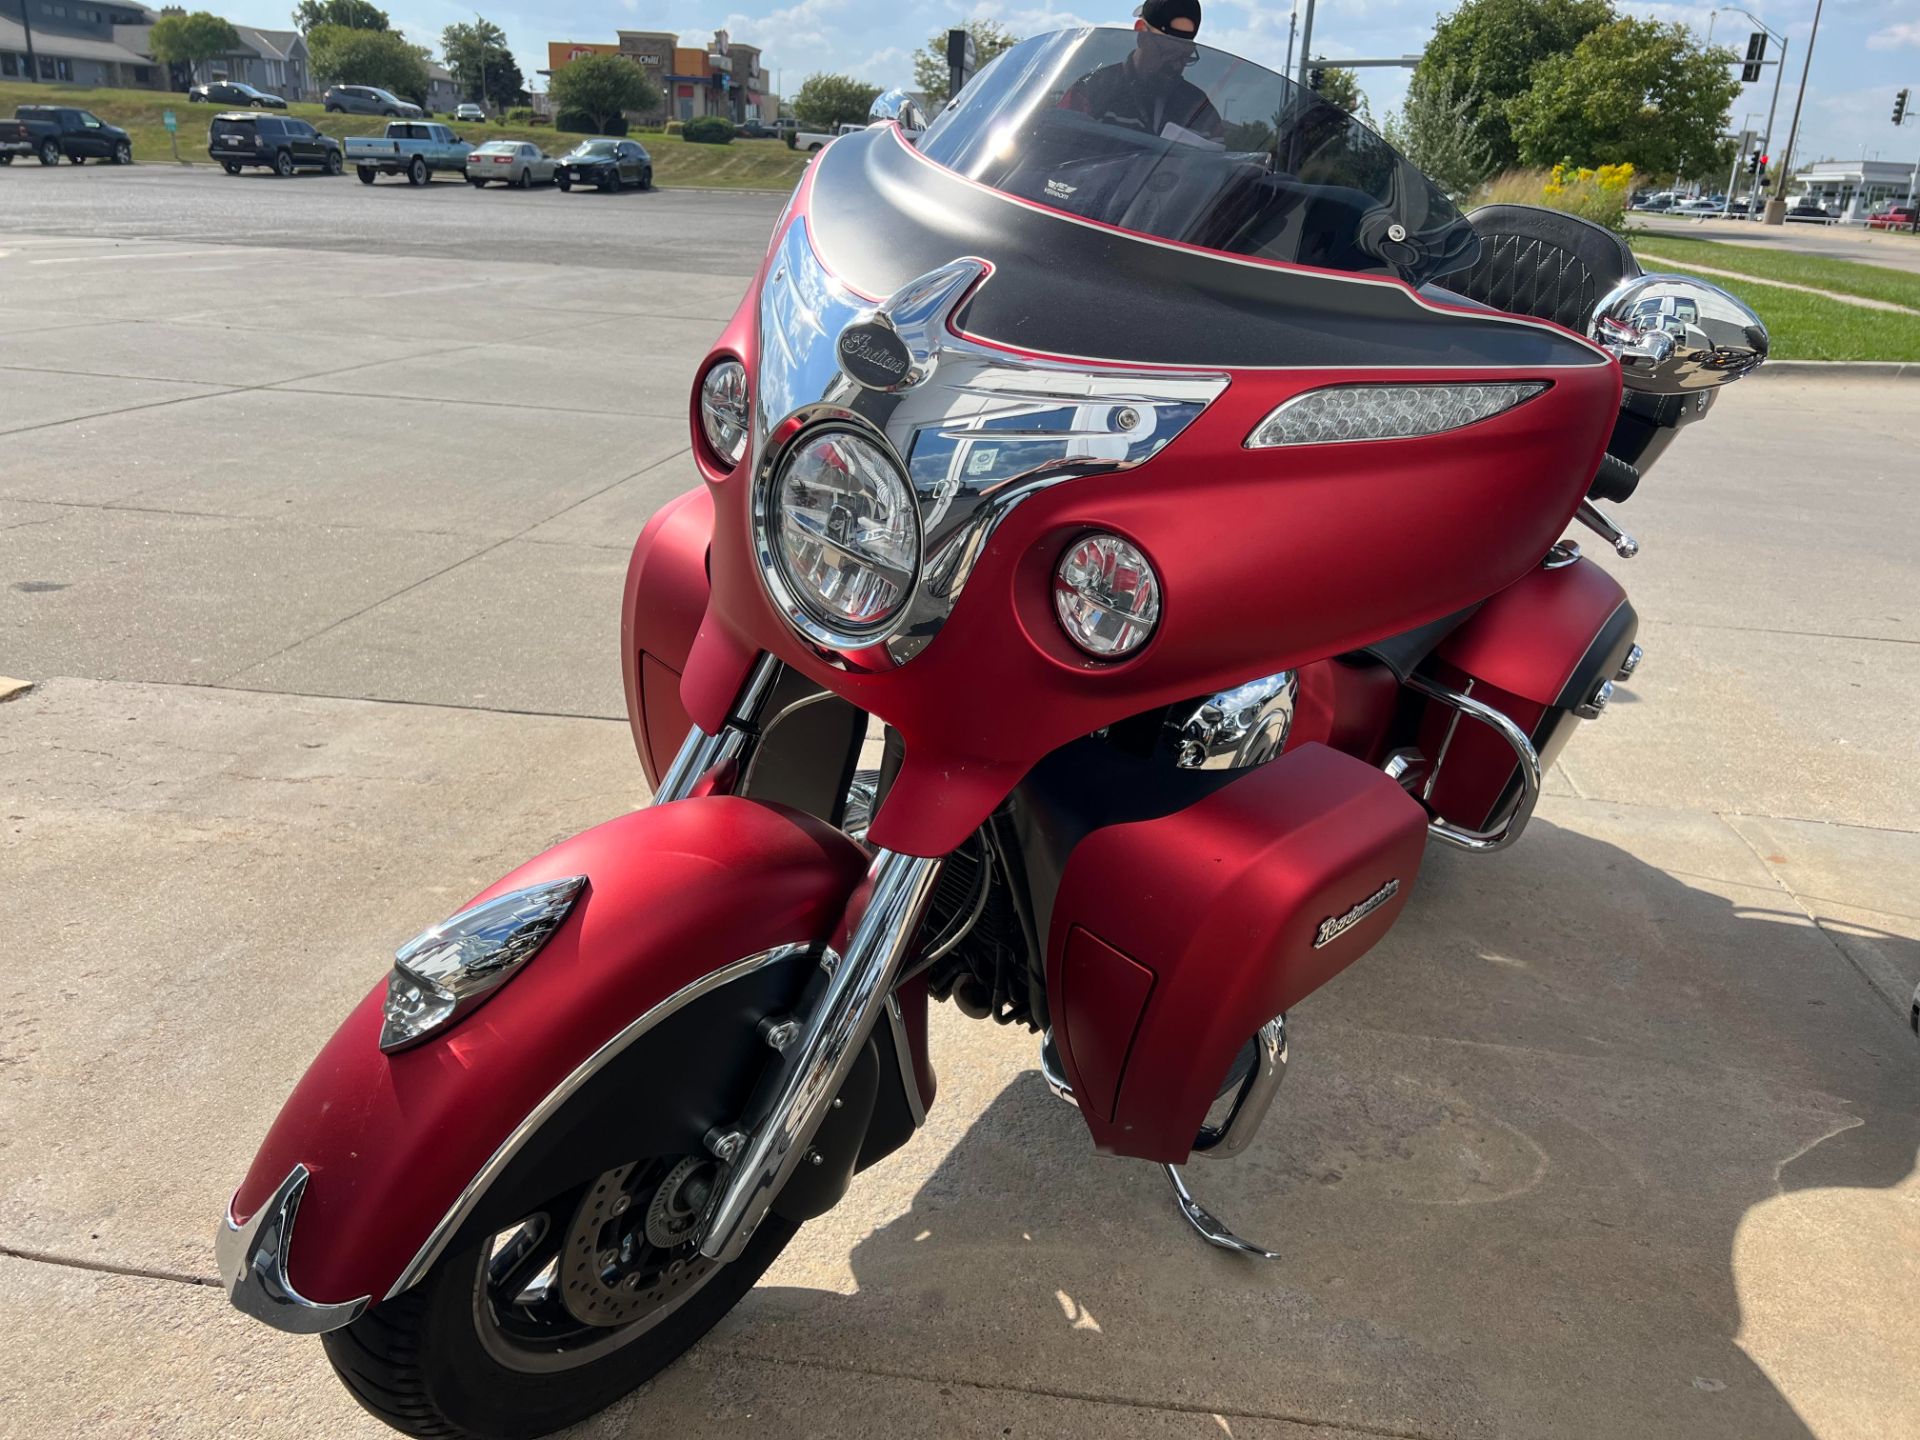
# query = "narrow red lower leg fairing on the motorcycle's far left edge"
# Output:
<box><xmin>620</xmin><ymin>488</ymin><xmax>714</xmax><ymax>785</ymax></box>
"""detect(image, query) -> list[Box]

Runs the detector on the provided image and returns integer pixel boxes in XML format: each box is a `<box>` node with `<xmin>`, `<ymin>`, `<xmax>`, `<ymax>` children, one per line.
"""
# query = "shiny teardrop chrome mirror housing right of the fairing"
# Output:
<box><xmin>1588</xmin><ymin>275</ymin><xmax>1768</xmax><ymax>396</ymax></box>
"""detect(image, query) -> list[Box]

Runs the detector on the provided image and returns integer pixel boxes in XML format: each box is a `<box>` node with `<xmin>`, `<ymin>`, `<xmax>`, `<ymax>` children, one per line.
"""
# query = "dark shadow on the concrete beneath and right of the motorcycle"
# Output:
<box><xmin>687</xmin><ymin>822</ymin><xmax>1920</xmax><ymax>1440</ymax></box>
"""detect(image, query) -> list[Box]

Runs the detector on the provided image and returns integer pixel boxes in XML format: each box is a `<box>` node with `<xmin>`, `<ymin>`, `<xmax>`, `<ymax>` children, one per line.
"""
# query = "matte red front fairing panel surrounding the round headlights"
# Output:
<box><xmin>682</xmin><ymin>186</ymin><xmax>1620</xmax><ymax>854</ymax></box>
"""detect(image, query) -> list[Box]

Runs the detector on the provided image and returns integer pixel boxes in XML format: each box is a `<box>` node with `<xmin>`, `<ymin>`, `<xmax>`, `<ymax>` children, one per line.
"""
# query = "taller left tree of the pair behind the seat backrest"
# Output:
<box><xmin>1413</xmin><ymin>0</ymin><xmax>1613</xmax><ymax>169</ymax></box>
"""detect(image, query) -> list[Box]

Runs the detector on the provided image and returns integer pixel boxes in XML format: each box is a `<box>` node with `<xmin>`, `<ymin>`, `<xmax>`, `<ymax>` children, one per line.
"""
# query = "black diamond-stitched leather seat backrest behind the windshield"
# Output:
<box><xmin>1442</xmin><ymin>205</ymin><xmax>1640</xmax><ymax>334</ymax></box>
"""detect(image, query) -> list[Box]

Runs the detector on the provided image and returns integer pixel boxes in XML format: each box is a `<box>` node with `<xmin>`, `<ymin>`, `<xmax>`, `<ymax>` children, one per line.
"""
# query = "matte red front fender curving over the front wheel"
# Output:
<box><xmin>232</xmin><ymin>797</ymin><xmax>866</xmax><ymax>1304</ymax></box>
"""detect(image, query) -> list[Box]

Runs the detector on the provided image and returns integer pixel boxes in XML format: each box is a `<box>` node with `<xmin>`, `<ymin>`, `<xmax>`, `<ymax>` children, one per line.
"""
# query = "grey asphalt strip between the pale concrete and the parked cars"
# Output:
<box><xmin>0</xmin><ymin>163</ymin><xmax>785</xmax><ymax>275</ymax></box>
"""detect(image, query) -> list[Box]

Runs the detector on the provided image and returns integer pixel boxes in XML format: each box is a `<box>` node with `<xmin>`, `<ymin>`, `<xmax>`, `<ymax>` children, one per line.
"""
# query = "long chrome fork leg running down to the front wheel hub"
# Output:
<box><xmin>701</xmin><ymin>851</ymin><xmax>943</xmax><ymax>1260</ymax></box>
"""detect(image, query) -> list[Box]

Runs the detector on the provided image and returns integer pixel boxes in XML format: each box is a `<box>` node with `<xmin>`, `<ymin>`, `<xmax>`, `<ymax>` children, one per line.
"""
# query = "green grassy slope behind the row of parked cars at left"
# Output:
<box><xmin>0</xmin><ymin>81</ymin><xmax>806</xmax><ymax>190</ymax></box>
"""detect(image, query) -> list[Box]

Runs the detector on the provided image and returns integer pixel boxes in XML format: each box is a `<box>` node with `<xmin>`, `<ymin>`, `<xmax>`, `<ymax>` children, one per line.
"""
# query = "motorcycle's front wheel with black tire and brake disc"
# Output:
<box><xmin>323</xmin><ymin>1154</ymin><xmax>797</xmax><ymax>1440</ymax></box>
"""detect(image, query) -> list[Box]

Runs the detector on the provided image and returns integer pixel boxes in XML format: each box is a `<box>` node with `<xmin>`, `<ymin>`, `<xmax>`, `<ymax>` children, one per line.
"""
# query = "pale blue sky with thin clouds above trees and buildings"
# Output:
<box><xmin>228</xmin><ymin>0</ymin><xmax>1920</xmax><ymax>163</ymax></box>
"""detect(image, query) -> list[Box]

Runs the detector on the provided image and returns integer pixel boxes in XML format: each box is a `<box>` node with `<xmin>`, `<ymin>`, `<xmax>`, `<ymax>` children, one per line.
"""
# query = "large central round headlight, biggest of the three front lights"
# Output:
<box><xmin>772</xmin><ymin>430</ymin><xmax>920</xmax><ymax>637</ymax></box>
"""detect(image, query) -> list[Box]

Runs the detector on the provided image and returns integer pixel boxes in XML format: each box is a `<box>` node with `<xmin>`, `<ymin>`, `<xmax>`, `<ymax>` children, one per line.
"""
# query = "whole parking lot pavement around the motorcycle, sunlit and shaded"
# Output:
<box><xmin>0</xmin><ymin>165</ymin><xmax>1920</xmax><ymax>1440</ymax></box>
